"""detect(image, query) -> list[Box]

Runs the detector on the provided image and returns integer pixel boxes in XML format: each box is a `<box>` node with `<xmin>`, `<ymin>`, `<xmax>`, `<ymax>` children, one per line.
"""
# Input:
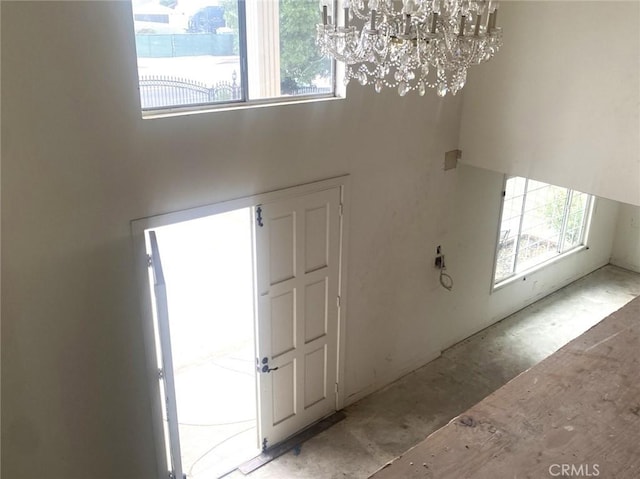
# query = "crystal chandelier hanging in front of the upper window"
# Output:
<box><xmin>316</xmin><ymin>0</ymin><xmax>502</xmax><ymax>97</ymax></box>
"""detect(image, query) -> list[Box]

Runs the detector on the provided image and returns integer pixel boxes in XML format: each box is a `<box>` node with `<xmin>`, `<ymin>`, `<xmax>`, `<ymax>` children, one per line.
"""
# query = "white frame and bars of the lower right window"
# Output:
<box><xmin>491</xmin><ymin>175</ymin><xmax>597</xmax><ymax>292</ymax></box>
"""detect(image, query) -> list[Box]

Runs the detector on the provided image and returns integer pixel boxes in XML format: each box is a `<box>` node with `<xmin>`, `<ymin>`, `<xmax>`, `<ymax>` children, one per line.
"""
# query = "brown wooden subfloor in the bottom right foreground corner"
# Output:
<box><xmin>371</xmin><ymin>298</ymin><xmax>640</xmax><ymax>479</ymax></box>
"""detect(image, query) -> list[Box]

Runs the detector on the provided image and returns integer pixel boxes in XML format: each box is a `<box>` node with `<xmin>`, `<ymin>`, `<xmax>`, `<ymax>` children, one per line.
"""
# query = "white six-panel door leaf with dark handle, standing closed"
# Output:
<box><xmin>255</xmin><ymin>187</ymin><xmax>342</xmax><ymax>449</ymax></box>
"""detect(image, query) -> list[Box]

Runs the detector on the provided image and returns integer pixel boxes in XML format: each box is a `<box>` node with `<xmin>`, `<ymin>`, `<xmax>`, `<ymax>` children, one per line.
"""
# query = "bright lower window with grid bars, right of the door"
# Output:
<box><xmin>493</xmin><ymin>176</ymin><xmax>593</xmax><ymax>287</ymax></box>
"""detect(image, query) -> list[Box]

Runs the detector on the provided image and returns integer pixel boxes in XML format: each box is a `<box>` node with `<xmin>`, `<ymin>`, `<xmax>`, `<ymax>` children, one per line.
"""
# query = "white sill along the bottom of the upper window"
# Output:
<box><xmin>142</xmin><ymin>95</ymin><xmax>345</xmax><ymax>120</ymax></box>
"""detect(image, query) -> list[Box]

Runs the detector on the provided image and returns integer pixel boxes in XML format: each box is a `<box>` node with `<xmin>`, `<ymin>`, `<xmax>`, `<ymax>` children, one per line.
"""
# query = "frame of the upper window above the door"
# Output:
<box><xmin>132</xmin><ymin>0</ymin><xmax>346</xmax><ymax>119</ymax></box>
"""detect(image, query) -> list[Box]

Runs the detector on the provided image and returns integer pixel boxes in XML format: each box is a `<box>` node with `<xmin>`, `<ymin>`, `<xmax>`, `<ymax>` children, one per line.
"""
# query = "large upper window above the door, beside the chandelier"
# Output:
<box><xmin>133</xmin><ymin>0</ymin><xmax>334</xmax><ymax>111</ymax></box>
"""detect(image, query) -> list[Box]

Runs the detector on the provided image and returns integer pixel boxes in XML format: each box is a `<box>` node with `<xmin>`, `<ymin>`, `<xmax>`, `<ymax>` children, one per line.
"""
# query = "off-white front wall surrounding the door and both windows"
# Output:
<box><xmin>1</xmin><ymin>1</ymin><xmax>628</xmax><ymax>479</ymax></box>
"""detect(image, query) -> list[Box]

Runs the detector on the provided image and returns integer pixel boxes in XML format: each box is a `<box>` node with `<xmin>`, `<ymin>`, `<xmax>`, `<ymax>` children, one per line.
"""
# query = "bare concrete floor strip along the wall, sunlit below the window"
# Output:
<box><xmin>227</xmin><ymin>266</ymin><xmax>640</xmax><ymax>479</ymax></box>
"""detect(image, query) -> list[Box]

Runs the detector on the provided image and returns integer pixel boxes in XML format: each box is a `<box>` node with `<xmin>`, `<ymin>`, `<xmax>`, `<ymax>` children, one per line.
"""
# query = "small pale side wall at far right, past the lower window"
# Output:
<box><xmin>611</xmin><ymin>204</ymin><xmax>640</xmax><ymax>273</ymax></box>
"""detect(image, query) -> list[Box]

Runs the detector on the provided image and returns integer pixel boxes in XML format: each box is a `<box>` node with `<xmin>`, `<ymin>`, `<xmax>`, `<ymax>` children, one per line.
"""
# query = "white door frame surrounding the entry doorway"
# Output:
<box><xmin>130</xmin><ymin>175</ymin><xmax>351</xmax><ymax>479</ymax></box>
